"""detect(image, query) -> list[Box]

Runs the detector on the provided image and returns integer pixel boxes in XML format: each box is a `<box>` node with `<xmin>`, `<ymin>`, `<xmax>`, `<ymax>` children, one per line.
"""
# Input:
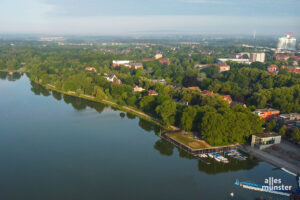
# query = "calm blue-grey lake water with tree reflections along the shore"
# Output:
<box><xmin>0</xmin><ymin>73</ymin><xmax>296</xmax><ymax>200</ymax></box>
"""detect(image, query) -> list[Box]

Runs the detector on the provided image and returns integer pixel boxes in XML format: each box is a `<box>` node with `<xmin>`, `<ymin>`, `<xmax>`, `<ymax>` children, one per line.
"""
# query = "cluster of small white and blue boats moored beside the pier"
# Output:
<box><xmin>197</xmin><ymin>150</ymin><xmax>247</xmax><ymax>163</ymax></box>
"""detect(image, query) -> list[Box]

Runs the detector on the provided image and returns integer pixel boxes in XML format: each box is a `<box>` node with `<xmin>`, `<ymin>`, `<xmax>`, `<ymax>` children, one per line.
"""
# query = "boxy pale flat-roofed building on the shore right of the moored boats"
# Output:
<box><xmin>251</xmin><ymin>133</ymin><xmax>281</xmax><ymax>149</ymax></box>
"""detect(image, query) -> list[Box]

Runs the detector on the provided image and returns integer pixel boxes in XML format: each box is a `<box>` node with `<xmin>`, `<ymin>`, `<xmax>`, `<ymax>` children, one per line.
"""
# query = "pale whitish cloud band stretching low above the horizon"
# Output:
<box><xmin>0</xmin><ymin>15</ymin><xmax>300</xmax><ymax>35</ymax></box>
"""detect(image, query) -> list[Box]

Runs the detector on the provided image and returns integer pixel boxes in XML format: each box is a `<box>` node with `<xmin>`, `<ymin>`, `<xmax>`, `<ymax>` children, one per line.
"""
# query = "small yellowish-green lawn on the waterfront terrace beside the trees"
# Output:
<box><xmin>166</xmin><ymin>132</ymin><xmax>211</xmax><ymax>149</ymax></box>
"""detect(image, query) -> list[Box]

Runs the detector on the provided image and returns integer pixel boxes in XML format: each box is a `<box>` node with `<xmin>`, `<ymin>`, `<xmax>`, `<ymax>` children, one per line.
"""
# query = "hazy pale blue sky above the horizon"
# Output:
<box><xmin>0</xmin><ymin>0</ymin><xmax>300</xmax><ymax>35</ymax></box>
